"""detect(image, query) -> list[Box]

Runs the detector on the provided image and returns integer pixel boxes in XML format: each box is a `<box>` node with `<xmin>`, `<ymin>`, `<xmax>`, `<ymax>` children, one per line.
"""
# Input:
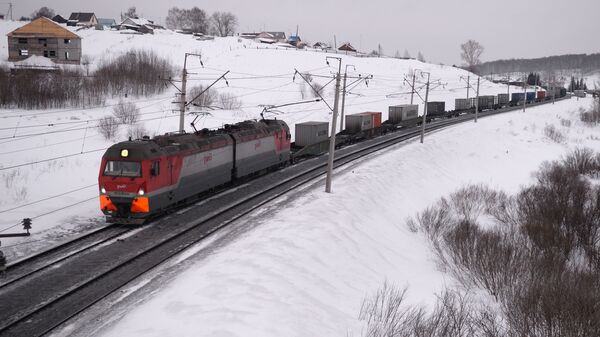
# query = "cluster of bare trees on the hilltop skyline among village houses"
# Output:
<box><xmin>166</xmin><ymin>7</ymin><xmax>238</xmax><ymax>36</ymax></box>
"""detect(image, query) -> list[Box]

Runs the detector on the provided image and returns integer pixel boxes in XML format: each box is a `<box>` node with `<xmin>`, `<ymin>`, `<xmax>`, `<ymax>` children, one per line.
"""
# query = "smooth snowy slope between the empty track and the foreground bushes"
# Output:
<box><xmin>49</xmin><ymin>94</ymin><xmax>600</xmax><ymax>337</ymax></box>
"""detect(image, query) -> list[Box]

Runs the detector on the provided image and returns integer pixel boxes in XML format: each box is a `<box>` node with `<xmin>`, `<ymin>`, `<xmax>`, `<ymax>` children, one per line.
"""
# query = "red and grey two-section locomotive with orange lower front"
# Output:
<box><xmin>98</xmin><ymin>119</ymin><xmax>291</xmax><ymax>224</ymax></box>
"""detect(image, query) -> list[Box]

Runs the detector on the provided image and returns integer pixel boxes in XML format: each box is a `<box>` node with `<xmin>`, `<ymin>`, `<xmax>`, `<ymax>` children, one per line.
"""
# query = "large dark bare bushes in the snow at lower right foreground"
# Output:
<box><xmin>380</xmin><ymin>149</ymin><xmax>600</xmax><ymax>337</ymax></box>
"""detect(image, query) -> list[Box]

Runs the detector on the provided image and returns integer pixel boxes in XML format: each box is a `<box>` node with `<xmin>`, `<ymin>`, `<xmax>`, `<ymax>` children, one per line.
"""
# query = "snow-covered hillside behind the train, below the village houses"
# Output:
<box><xmin>0</xmin><ymin>21</ymin><xmax>515</xmax><ymax>260</ymax></box>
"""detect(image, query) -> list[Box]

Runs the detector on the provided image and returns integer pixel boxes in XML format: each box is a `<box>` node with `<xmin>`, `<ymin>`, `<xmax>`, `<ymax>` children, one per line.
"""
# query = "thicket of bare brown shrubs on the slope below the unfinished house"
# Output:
<box><xmin>0</xmin><ymin>50</ymin><xmax>173</xmax><ymax>109</ymax></box>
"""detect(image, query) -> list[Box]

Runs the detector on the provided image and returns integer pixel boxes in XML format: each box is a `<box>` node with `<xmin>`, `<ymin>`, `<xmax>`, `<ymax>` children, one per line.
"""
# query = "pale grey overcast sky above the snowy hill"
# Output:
<box><xmin>8</xmin><ymin>0</ymin><xmax>600</xmax><ymax>64</ymax></box>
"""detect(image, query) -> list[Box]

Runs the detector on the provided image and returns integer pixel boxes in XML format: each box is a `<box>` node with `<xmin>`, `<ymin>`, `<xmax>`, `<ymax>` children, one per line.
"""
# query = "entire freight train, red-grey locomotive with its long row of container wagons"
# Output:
<box><xmin>98</xmin><ymin>88</ymin><xmax>564</xmax><ymax>224</ymax></box>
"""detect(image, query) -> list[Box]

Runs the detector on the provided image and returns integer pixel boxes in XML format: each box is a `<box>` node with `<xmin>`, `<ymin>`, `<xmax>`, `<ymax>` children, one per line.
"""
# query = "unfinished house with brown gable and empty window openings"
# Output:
<box><xmin>7</xmin><ymin>17</ymin><xmax>81</xmax><ymax>64</ymax></box>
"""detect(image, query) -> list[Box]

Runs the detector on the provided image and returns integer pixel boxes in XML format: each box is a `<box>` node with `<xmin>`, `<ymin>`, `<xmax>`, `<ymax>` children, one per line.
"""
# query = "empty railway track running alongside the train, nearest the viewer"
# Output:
<box><xmin>0</xmin><ymin>96</ymin><xmax>568</xmax><ymax>336</ymax></box>
